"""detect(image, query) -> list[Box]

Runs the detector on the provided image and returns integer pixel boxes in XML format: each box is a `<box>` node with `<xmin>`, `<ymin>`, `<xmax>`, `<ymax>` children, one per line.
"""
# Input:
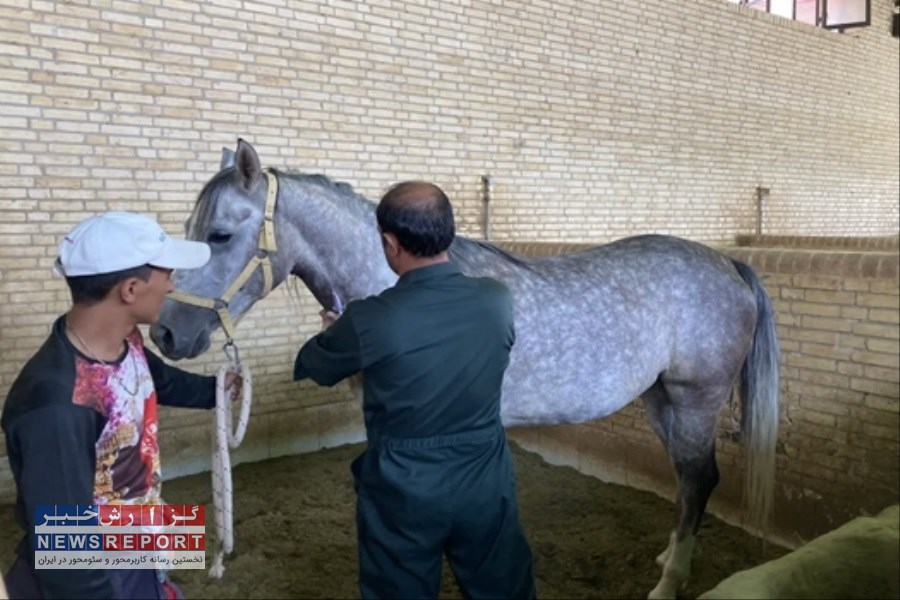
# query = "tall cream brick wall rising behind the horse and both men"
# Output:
<box><xmin>0</xmin><ymin>0</ymin><xmax>900</xmax><ymax>528</ymax></box>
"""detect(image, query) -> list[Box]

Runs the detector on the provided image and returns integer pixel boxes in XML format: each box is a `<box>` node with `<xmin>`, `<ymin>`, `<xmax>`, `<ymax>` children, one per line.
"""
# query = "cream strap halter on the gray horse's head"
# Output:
<box><xmin>168</xmin><ymin>170</ymin><xmax>278</xmax><ymax>342</ymax></box>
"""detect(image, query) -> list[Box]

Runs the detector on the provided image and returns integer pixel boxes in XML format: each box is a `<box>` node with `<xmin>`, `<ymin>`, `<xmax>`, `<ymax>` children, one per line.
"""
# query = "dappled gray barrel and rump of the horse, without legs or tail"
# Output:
<box><xmin>453</xmin><ymin>235</ymin><xmax>756</xmax><ymax>423</ymax></box>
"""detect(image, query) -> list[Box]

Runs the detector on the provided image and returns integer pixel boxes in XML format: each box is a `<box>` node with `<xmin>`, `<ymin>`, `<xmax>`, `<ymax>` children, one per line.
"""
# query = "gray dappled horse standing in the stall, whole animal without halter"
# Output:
<box><xmin>151</xmin><ymin>140</ymin><xmax>779</xmax><ymax>598</ymax></box>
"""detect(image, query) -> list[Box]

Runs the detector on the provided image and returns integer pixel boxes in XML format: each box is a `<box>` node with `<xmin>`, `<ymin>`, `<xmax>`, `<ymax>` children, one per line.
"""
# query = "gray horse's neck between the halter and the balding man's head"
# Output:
<box><xmin>277</xmin><ymin>176</ymin><xmax>396</xmax><ymax>308</ymax></box>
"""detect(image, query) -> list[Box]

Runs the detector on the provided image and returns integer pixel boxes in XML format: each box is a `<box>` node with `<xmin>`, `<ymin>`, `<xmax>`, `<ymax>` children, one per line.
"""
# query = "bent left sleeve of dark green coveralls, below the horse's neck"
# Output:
<box><xmin>294</xmin><ymin>306</ymin><xmax>362</xmax><ymax>386</ymax></box>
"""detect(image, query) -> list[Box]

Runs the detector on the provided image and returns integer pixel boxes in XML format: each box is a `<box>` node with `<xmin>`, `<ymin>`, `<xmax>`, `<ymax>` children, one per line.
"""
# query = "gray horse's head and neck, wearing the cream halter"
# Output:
<box><xmin>150</xmin><ymin>140</ymin><xmax>395</xmax><ymax>359</ymax></box>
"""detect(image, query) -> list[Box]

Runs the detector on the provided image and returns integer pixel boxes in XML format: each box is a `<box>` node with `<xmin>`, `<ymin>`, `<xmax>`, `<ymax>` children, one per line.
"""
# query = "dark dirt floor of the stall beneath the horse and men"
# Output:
<box><xmin>0</xmin><ymin>444</ymin><xmax>787</xmax><ymax>599</ymax></box>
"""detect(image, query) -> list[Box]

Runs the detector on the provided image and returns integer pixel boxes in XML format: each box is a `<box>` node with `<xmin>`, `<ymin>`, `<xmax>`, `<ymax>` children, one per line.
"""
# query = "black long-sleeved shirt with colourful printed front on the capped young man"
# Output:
<box><xmin>0</xmin><ymin>317</ymin><xmax>215</xmax><ymax>598</ymax></box>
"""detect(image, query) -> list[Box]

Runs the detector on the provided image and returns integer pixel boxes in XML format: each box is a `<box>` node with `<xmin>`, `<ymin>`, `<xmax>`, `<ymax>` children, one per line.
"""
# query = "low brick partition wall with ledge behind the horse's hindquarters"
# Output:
<box><xmin>505</xmin><ymin>238</ymin><xmax>900</xmax><ymax>545</ymax></box>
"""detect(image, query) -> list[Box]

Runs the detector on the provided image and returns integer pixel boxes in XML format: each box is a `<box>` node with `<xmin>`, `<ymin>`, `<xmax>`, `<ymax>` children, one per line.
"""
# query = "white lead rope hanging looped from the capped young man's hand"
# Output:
<box><xmin>209</xmin><ymin>349</ymin><xmax>253</xmax><ymax>579</ymax></box>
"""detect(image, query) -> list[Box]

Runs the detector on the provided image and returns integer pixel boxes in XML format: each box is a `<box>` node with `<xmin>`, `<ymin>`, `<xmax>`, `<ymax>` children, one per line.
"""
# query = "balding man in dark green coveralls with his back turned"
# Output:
<box><xmin>294</xmin><ymin>181</ymin><xmax>536</xmax><ymax>598</ymax></box>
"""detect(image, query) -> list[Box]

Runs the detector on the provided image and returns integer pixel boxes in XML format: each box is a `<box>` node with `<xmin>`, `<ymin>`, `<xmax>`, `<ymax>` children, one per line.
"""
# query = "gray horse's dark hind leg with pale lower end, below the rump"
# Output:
<box><xmin>644</xmin><ymin>385</ymin><xmax>725</xmax><ymax>598</ymax></box>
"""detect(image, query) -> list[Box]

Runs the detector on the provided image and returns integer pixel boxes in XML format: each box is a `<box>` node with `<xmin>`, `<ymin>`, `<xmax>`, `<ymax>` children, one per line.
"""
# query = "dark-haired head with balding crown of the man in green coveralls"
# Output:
<box><xmin>375</xmin><ymin>181</ymin><xmax>456</xmax><ymax>257</ymax></box>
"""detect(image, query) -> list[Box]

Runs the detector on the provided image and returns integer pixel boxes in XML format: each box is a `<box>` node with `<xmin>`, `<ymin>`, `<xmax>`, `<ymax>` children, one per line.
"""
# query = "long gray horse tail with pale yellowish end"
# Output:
<box><xmin>732</xmin><ymin>260</ymin><xmax>780</xmax><ymax>537</ymax></box>
